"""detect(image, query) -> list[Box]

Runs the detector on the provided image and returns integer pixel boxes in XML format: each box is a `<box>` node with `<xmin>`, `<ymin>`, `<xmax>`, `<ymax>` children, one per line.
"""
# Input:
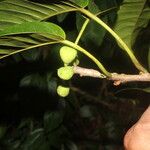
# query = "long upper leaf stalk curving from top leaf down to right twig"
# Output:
<box><xmin>79</xmin><ymin>8</ymin><xmax>148</xmax><ymax>73</ymax></box>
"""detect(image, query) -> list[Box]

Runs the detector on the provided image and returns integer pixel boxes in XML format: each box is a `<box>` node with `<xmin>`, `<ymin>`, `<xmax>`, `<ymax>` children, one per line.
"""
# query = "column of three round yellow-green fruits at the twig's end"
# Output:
<box><xmin>57</xmin><ymin>46</ymin><xmax>77</xmax><ymax>97</ymax></box>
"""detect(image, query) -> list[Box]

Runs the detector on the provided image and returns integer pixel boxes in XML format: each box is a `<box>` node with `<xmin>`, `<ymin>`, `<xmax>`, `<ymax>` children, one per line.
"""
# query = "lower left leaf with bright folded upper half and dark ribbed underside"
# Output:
<box><xmin>0</xmin><ymin>22</ymin><xmax>65</xmax><ymax>59</ymax></box>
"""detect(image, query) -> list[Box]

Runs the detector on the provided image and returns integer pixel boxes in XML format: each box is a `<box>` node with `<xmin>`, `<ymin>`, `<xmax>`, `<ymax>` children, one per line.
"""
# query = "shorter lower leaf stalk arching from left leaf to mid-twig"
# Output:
<box><xmin>60</xmin><ymin>40</ymin><xmax>111</xmax><ymax>77</ymax></box>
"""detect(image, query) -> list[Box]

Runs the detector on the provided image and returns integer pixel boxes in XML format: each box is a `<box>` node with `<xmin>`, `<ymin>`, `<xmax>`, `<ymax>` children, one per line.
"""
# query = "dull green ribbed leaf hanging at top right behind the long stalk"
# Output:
<box><xmin>114</xmin><ymin>0</ymin><xmax>146</xmax><ymax>48</ymax></box>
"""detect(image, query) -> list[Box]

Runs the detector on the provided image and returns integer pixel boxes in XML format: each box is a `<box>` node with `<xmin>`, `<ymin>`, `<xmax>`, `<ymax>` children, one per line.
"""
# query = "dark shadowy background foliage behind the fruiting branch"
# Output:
<box><xmin>0</xmin><ymin>0</ymin><xmax>150</xmax><ymax>150</ymax></box>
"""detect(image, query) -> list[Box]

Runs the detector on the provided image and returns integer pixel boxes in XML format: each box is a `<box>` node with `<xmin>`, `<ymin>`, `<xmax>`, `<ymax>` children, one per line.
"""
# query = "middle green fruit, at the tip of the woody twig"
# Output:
<box><xmin>57</xmin><ymin>66</ymin><xmax>74</xmax><ymax>80</ymax></box>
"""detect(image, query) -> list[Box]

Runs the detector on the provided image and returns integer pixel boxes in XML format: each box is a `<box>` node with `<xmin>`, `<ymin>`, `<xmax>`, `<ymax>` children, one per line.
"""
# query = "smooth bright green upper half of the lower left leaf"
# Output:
<box><xmin>0</xmin><ymin>22</ymin><xmax>65</xmax><ymax>40</ymax></box>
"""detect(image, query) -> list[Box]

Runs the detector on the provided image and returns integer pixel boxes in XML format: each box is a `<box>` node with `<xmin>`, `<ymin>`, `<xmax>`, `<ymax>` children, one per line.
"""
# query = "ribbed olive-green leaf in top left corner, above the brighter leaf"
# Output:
<box><xmin>0</xmin><ymin>0</ymin><xmax>78</xmax><ymax>30</ymax></box>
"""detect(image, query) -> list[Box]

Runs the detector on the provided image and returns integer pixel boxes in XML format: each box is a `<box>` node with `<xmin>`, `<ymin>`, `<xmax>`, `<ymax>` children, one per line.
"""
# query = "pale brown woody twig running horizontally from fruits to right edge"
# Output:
<box><xmin>74</xmin><ymin>66</ymin><xmax>150</xmax><ymax>86</ymax></box>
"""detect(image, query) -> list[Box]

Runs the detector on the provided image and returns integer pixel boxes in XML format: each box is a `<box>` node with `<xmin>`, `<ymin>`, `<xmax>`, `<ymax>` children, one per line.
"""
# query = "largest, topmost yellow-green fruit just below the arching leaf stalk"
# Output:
<box><xmin>60</xmin><ymin>46</ymin><xmax>77</xmax><ymax>64</ymax></box>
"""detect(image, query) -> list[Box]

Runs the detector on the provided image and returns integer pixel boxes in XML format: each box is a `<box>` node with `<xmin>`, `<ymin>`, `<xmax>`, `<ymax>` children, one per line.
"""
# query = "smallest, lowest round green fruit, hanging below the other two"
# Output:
<box><xmin>57</xmin><ymin>85</ymin><xmax>70</xmax><ymax>97</ymax></box>
